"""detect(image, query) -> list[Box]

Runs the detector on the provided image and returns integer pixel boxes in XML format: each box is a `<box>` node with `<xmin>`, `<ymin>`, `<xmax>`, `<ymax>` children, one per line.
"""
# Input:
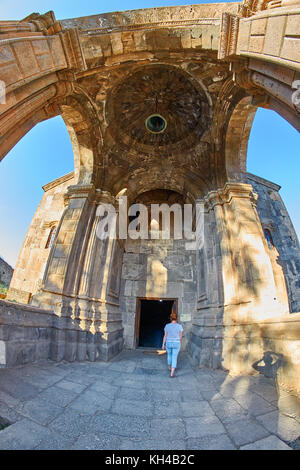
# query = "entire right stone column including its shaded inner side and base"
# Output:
<box><xmin>192</xmin><ymin>183</ymin><xmax>287</xmax><ymax>373</ymax></box>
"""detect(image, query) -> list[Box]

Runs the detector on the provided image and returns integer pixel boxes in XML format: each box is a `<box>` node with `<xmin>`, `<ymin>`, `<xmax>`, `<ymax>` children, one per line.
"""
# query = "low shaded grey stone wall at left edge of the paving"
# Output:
<box><xmin>0</xmin><ymin>300</ymin><xmax>107</xmax><ymax>367</ymax></box>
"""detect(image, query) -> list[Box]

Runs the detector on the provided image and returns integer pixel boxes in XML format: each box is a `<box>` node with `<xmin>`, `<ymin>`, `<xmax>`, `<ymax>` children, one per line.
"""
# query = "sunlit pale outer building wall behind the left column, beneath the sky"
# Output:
<box><xmin>7</xmin><ymin>173</ymin><xmax>73</xmax><ymax>303</ymax></box>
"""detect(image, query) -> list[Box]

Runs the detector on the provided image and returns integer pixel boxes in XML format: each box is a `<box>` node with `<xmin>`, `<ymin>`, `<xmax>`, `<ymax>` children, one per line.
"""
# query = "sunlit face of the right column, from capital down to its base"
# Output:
<box><xmin>207</xmin><ymin>183</ymin><xmax>286</xmax><ymax>374</ymax></box>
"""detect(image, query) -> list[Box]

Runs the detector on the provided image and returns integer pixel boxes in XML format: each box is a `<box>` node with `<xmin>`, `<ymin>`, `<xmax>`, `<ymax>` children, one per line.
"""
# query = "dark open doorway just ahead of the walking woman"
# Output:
<box><xmin>137</xmin><ymin>299</ymin><xmax>177</xmax><ymax>348</ymax></box>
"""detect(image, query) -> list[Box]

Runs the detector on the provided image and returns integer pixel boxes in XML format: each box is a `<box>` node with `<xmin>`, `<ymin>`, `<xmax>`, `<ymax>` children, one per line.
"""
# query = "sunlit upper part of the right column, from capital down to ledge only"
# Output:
<box><xmin>206</xmin><ymin>183</ymin><xmax>285</xmax><ymax>322</ymax></box>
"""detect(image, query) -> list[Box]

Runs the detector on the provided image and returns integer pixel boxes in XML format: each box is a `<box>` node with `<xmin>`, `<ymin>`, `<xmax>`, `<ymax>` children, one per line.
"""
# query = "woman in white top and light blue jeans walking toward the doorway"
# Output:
<box><xmin>162</xmin><ymin>309</ymin><xmax>183</xmax><ymax>377</ymax></box>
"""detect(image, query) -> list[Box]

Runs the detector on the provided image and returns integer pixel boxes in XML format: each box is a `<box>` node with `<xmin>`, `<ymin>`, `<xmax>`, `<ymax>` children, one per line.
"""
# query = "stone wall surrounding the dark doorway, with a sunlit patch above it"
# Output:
<box><xmin>120</xmin><ymin>239</ymin><xmax>197</xmax><ymax>349</ymax></box>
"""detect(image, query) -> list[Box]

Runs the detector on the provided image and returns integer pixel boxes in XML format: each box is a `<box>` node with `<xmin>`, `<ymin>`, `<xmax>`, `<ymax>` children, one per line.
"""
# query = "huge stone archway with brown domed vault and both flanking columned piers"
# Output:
<box><xmin>0</xmin><ymin>1</ymin><xmax>300</xmax><ymax>392</ymax></box>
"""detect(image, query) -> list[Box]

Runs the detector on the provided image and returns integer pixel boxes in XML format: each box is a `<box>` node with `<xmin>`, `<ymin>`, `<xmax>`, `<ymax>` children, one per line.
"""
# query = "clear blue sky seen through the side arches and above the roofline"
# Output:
<box><xmin>0</xmin><ymin>0</ymin><xmax>300</xmax><ymax>266</ymax></box>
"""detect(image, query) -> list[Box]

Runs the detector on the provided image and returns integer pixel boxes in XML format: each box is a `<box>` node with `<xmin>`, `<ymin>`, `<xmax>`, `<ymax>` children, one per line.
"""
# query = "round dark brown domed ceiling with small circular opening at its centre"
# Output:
<box><xmin>106</xmin><ymin>65</ymin><xmax>210</xmax><ymax>154</ymax></box>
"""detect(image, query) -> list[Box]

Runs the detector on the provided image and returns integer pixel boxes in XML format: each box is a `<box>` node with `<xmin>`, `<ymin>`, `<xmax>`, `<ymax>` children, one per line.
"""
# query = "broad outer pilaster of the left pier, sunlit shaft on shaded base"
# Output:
<box><xmin>31</xmin><ymin>185</ymin><xmax>95</xmax><ymax>360</ymax></box>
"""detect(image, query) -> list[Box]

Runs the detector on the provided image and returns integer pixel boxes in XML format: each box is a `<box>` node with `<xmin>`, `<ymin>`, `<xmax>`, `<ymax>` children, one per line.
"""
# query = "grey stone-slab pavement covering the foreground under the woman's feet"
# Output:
<box><xmin>0</xmin><ymin>350</ymin><xmax>300</xmax><ymax>450</ymax></box>
